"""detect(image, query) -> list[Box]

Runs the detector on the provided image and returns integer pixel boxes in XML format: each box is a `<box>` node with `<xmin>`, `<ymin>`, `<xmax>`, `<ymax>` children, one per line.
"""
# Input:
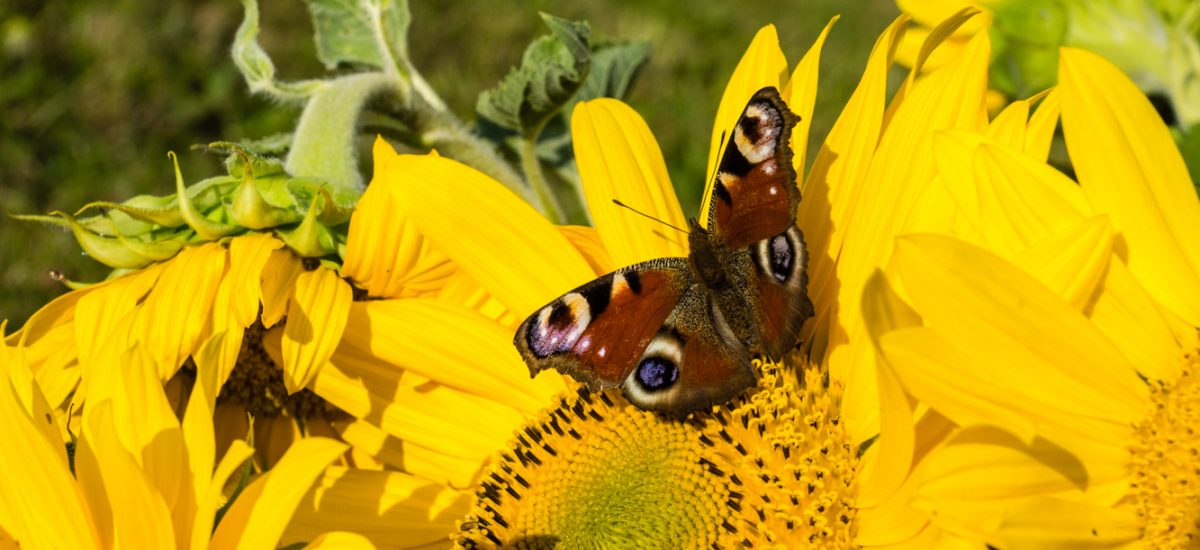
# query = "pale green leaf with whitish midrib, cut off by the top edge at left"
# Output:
<box><xmin>305</xmin><ymin>0</ymin><xmax>412</xmax><ymax>72</ymax></box>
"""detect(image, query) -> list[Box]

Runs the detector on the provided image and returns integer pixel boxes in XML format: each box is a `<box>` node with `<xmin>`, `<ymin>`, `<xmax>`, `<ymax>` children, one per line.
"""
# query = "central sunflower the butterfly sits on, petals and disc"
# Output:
<box><xmin>265</xmin><ymin>11</ymin><xmax>1054</xmax><ymax>546</ymax></box>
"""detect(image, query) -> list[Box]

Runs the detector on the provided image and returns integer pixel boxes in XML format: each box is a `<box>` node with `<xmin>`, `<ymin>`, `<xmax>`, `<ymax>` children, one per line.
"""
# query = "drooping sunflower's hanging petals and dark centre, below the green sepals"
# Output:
<box><xmin>7</xmin><ymin>214</ymin><xmax>352</xmax><ymax>468</ymax></box>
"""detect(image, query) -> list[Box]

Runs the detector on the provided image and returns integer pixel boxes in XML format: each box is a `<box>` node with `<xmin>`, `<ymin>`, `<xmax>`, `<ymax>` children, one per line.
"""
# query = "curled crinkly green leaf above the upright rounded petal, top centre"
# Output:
<box><xmin>475</xmin><ymin>13</ymin><xmax>592</xmax><ymax>137</ymax></box>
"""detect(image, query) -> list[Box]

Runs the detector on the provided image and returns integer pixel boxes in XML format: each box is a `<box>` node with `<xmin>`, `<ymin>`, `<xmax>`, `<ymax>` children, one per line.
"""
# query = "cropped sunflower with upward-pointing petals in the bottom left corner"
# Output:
<box><xmin>0</xmin><ymin>324</ymin><xmax>346</xmax><ymax>549</ymax></box>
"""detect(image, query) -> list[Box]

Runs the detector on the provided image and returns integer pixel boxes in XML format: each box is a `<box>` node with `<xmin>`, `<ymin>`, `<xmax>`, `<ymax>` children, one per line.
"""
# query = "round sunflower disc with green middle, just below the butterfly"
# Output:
<box><xmin>452</xmin><ymin>361</ymin><xmax>858</xmax><ymax>548</ymax></box>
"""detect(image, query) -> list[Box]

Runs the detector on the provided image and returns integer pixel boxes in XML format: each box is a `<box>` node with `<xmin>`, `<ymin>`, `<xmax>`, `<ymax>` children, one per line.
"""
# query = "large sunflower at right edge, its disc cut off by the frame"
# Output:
<box><xmin>865</xmin><ymin>49</ymin><xmax>1200</xmax><ymax>548</ymax></box>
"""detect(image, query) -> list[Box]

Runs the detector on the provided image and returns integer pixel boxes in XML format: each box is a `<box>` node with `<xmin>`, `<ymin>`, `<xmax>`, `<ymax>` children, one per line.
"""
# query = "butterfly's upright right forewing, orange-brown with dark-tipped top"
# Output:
<box><xmin>708</xmin><ymin>88</ymin><xmax>800</xmax><ymax>249</ymax></box>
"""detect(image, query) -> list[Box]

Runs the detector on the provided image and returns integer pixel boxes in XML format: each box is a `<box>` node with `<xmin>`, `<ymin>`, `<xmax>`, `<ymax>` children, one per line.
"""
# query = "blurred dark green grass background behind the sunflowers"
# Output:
<box><xmin>0</xmin><ymin>0</ymin><xmax>898</xmax><ymax>330</ymax></box>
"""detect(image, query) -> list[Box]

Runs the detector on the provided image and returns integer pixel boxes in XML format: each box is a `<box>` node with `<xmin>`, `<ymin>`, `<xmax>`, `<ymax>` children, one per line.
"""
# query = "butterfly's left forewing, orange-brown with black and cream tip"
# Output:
<box><xmin>514</xmin><ymin>258</ymin><xmax>691</xmax><ymax>389</ymax></box>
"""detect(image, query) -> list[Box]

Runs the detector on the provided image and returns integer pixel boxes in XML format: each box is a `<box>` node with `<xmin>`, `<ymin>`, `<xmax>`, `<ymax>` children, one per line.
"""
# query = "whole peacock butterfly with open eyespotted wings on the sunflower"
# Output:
<box><xmin>514</xmin><ymin>88</ymin><xmax>812</xmax><ymax>417</ymax></box>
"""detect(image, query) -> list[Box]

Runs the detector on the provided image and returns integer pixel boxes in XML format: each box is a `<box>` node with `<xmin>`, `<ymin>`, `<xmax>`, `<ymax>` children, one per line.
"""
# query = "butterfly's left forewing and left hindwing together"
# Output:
<box><xmin>514</xmin><ymin>258</ymin><xmax>755</xmax><ymax>417</ymax></box>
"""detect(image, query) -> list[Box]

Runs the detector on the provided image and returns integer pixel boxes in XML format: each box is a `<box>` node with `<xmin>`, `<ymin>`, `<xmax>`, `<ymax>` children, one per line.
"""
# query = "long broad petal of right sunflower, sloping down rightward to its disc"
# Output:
<box><xmin>893</xmin><ymin>235</ymin><xmax>1146</xmax><ymax>423</ymax></box>
